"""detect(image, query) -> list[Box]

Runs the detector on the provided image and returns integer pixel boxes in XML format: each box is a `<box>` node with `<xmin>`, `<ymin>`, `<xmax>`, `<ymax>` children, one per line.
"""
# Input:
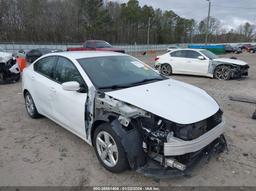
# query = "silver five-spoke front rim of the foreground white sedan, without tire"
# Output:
<box><xmin>96</xmin><ymin>131</ymin><xmax>118</xmax><ymax>167</ymax></box>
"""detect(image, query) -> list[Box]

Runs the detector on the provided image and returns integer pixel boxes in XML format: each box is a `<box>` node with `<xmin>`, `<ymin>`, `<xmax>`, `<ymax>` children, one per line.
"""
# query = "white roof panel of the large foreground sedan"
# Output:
<box><xmin>47</xmin><ymin>51</ymin><xmax>126</xmax><ymax>59</ymax></box>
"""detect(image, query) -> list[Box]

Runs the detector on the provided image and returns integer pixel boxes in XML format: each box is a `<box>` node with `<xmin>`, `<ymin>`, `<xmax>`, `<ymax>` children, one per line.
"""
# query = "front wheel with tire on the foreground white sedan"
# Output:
<box><xmin>93</xmin><ymin>123</ymin><xmax>129</xmax><ymax>173</ymax></box>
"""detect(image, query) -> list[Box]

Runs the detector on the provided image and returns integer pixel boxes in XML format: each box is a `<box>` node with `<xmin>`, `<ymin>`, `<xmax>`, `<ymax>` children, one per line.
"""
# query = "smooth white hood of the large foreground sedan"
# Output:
<box><xmin>106</xmin><ymin>79</ymin><xmax>219</xmax><ymax>124</ymax></box>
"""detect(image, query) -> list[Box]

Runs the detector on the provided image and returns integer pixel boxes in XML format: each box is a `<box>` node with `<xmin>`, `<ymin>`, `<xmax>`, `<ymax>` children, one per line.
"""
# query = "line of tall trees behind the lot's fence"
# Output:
<box><xmin>0</xmin><ymin>0</ymin><xmax>255</xmax><ymax>44</ymax></box>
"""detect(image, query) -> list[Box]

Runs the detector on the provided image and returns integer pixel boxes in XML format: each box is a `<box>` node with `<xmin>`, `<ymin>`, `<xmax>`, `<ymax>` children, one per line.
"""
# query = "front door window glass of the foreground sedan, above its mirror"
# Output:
<box><xmin>54</xmin><ymin>57</ymin><xmax>84</xmax><ymax>85</ymax></box>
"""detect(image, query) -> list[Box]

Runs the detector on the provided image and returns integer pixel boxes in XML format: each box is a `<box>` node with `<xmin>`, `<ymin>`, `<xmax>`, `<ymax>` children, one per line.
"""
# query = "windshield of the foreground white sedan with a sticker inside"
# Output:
<box><xmin>78</xmin><ymin>56</ymin><xmax>167</xmax><ymax>89</ymax></box>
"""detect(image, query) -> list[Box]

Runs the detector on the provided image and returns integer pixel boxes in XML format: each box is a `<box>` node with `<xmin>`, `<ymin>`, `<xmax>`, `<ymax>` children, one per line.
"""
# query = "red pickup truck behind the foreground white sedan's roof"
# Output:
<box><xmin>67</xmin><ymin>40</ymin><xmax>125</xmax><ymax>53</ymax></box>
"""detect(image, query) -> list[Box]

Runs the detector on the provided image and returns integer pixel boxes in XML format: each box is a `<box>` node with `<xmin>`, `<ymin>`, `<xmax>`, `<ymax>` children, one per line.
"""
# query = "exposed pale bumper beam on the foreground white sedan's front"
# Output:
<box><xmin>164</xmin><ymin>122</ymin><xmax>224</xmax><ymax>156</ymax></box>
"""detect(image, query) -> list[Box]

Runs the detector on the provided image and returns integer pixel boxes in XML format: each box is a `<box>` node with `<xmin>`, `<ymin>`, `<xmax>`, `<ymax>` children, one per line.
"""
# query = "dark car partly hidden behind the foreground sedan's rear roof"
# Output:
<box><xmin>26</xmin><ymin>48</ymin><xmax>62</xmax><ymax>63</ymax></box>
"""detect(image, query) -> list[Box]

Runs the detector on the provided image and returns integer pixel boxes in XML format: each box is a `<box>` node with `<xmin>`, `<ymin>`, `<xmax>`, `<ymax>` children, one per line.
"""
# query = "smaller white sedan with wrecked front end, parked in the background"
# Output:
<box><xmin>155</xmin><ymin>49</ymin><xmax>249</xmax><ymax>80</ymax></box>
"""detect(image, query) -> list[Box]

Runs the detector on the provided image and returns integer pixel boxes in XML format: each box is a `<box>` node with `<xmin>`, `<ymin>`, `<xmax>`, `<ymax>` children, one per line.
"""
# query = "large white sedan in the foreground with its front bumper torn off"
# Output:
<box><xmin>23</xmin><ymin>51</ymin><xmax>226</xmax><ymax>175</ymax></box>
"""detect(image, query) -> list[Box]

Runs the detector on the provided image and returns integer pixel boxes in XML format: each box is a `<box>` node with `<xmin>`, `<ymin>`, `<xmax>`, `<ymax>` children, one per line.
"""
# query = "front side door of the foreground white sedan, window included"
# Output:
<box><xmin>52</xmin><ymin>57</ymin><xmax>88</xmax><ymax>139</ymax></box>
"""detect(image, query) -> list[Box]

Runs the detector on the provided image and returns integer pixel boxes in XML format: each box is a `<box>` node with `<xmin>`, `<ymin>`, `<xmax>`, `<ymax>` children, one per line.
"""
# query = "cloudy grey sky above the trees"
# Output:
<box><xmin>114</xmin><ymin>0</ymin><xmax>256</xmax><ymax>29</ymax></box>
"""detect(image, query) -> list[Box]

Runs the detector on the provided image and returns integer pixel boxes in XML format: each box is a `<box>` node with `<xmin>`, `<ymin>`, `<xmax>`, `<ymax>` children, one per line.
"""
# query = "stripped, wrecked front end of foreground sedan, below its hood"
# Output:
<box><xmin>94</xmin><ymin>93</ymin><xmax>226</xmax><ymax>177</ymax></box>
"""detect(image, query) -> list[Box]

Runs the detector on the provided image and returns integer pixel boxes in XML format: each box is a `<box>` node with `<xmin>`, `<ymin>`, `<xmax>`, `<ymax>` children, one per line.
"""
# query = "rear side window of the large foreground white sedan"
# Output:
<box><xmin>34</xmin><ymin>56</ymin><xmax>56</xmax><ymax>78</ymax></box>
